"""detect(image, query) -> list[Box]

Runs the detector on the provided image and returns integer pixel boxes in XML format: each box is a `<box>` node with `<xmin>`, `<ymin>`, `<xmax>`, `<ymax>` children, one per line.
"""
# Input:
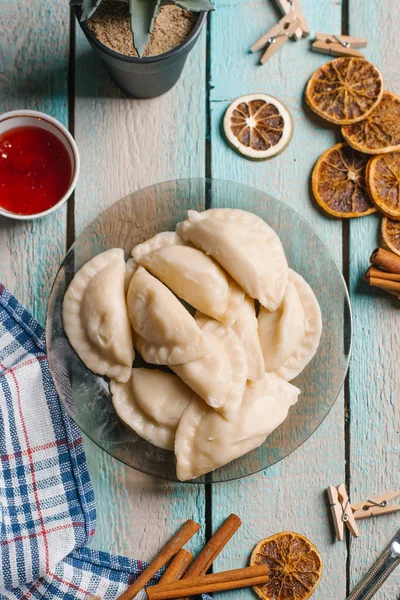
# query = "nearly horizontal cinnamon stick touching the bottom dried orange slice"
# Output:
<box><xmin>146</xmin><ymin>565</ymin><xmax>268</xmax><ymax>600</ymax></box>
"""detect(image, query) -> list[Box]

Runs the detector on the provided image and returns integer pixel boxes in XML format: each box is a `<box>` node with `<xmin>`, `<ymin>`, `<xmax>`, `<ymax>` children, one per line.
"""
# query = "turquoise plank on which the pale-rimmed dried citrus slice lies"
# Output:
<box><xmin>211</xmin><ymin>0</ymin><xmax>346</xmax><ymax>600</ymax></box>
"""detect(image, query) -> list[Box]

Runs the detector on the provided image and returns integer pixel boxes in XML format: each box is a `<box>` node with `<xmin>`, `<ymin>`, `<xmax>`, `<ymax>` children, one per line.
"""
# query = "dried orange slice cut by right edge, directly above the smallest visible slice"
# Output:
<box><xmin>367</xmin><ymin>152</ymin><xmax>400</xmax><ymax>220</ymax></box>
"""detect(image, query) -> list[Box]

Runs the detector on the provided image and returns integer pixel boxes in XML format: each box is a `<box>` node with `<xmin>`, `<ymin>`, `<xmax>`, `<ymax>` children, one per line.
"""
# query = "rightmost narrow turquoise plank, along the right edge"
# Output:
<box><xmin>349</xmin><ymin>0</ymin><xmax>400</xmax><ymax>600</ymax></box>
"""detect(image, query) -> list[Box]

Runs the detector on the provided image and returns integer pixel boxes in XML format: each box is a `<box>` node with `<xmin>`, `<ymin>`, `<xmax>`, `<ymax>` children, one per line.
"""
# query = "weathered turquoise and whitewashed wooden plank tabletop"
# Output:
<box><xmin>0</xmin><ymin>0</ymin><xmax>400</xmax><ymax>600</ymax></box>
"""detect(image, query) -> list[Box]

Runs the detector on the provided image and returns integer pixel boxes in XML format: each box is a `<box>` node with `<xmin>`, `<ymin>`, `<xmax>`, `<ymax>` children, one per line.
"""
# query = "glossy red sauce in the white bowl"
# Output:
<box><xmin>0</xmin><ymin>126</ymin><xmax>72</xmax><ymax>215</ymax></box>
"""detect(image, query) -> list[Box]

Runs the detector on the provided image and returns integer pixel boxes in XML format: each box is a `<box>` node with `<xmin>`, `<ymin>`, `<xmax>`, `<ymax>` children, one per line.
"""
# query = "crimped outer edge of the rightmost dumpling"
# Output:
<box><xmin>276</xmin><ymin>270</ymin><xmax>322</xmax><ymax>381</ymax></box>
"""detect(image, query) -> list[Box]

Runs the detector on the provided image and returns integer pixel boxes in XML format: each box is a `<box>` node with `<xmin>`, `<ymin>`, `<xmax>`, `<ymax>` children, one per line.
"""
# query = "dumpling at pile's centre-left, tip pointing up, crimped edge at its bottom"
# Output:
<box><xmin>127</xmin><ymin>267</ymin><xmax>209</xmax><ymax>365</ymax></box>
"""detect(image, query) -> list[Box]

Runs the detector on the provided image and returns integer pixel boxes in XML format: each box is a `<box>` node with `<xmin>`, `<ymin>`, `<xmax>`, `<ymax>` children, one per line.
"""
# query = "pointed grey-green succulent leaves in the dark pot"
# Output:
<box><xmin>70</xmin><ymin>0</ymin><xmax>214</xmax><ymax>57</ymax></box>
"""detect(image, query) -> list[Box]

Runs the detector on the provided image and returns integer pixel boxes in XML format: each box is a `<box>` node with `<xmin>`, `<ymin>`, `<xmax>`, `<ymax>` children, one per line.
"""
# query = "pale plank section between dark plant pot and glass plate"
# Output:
<box><xmin>75</xmin><ymin>26</ymin><xmax>205</xmax><ymax>234</ymax></box>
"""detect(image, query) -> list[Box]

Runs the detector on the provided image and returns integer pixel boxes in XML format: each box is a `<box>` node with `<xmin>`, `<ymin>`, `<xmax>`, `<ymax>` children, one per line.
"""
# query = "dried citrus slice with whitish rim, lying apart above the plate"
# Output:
<box><xmin>223</xmin><ymin>94</ymin><xmax>293</xmax><ymax>160</ymax></box>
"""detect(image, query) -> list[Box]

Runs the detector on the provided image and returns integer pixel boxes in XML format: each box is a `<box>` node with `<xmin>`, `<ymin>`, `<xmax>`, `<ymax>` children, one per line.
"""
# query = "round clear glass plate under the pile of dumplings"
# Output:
<box><xmin>46</xmin><ymin>179</ymin><xmax>351</xmax><ymax>483</ymax></box>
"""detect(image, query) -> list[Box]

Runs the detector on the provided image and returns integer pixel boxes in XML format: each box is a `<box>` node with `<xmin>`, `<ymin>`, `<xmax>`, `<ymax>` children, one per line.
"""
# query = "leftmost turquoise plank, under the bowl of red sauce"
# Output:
<box><xmin>0</xmin><ymin>0</ymin><xmax>69</xmax><ymax>324</ymax></box>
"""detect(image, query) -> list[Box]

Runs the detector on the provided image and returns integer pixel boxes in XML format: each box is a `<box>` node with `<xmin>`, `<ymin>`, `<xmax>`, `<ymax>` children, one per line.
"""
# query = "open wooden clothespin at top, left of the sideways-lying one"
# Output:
<box><xmin>251</xmin><ymin>0</ymin><xmax>310</xmax><ymax>64</ymax></box>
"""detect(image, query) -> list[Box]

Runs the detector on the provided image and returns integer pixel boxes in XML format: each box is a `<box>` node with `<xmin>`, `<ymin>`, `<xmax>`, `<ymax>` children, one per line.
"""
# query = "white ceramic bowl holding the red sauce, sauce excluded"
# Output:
<box><xmin>0</xmin><ymin>110</ymin><xmax>80</xmax><ymax>221</ymax></box>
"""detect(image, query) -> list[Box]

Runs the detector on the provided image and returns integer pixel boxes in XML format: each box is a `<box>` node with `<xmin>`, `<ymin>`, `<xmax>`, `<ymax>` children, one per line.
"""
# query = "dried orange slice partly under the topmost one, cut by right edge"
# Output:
<box><xmin>342</xmin><ymin>92</ymin><xmax>400</xmax><ymax>154</ymax></box>
